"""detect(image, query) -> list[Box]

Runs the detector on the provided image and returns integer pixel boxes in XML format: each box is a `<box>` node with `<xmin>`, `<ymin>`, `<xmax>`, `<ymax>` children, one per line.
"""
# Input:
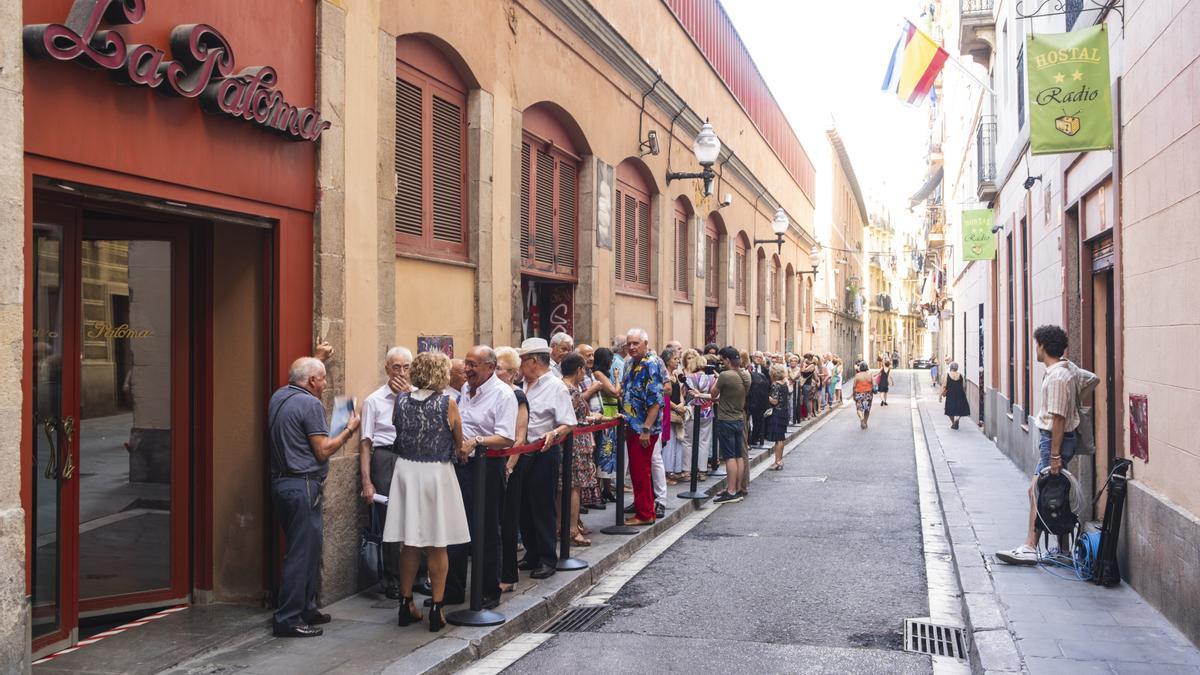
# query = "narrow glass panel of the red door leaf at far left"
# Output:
<box><xmin>30</xmin><ymin>223</ymin><xmax>71</xmax><ymax>639</ymax></box>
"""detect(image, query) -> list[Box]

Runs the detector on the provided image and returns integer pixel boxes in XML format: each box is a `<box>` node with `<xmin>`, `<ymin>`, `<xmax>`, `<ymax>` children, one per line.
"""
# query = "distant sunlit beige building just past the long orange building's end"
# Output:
<box><xmin>802</xmin><ymin>129</ymin><xmax>866</xmax><ymax>365</ymax></box>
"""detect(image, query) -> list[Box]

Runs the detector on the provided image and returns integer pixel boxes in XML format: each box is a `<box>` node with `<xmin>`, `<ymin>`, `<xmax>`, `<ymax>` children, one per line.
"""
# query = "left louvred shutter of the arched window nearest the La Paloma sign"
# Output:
<box><xmin>395</xmin><ymin>78</ymin><xmax>425</xmax><ymax>238</ymax></box>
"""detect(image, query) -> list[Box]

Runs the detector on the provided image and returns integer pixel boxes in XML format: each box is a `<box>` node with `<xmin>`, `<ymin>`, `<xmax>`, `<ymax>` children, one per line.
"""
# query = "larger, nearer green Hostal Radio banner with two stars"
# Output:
<box><xmin>1025</xmin><ymin>24</ymin><xmax>1112</xmax><ymax>155</ymax></box>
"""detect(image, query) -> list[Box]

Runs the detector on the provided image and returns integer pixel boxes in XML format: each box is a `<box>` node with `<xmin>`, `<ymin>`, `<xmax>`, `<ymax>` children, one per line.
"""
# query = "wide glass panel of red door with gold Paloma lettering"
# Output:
<box><xmin>78</xmin><ymin>239</ymin><xmax>174</xmax><ymax>595</ymax></box>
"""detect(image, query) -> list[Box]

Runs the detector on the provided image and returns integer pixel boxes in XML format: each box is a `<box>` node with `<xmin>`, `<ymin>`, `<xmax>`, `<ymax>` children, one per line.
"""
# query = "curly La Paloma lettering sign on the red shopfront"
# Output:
<box><xmin>24</xmin><ymin>0</ymin><xmax>330</xmax><ymax>141</ymax></box>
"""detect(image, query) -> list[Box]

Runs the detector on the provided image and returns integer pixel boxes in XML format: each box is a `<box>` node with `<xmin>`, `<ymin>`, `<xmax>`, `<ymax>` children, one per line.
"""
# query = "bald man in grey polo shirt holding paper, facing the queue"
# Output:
<box><xmin>266</xmin><ymin>357</ymin><xmax>359</xmax><ymax>638</ymax></box>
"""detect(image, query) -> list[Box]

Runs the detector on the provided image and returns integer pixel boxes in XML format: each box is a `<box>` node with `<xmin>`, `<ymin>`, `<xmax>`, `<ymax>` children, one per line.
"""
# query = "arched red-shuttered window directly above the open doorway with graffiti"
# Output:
<box><xmin>521</xmin><ymin>106</ymin><xmax>580</xmax><ymax>280</ymax></box>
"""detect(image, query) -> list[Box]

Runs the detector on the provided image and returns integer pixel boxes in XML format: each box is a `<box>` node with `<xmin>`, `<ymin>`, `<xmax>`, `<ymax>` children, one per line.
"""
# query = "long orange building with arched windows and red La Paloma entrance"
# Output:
<box><xmin>0</xmin><ymin>0</ymin><xmax>816</xmax><ymax>671</ymax></box>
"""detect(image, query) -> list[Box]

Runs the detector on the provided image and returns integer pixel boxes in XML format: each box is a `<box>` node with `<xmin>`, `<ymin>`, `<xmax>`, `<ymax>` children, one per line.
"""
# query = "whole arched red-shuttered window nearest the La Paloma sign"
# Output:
<box><xmin>395</xmin><ymin>37</ymin><xmax>468</xmax><ymax>259</ymax></box>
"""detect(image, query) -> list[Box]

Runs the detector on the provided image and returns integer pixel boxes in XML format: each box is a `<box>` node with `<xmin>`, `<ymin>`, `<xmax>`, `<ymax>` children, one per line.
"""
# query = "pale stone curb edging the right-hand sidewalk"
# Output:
<box><xmin>912</xmin><ymin>390</ymin><xmax>1027</xmax><ymax>673</ymax></box>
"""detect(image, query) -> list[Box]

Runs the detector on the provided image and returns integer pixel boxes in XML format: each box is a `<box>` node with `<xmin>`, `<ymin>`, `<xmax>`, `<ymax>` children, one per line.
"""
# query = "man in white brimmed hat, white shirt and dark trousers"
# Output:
<box><xmin>518</xmin><ymin>338</ymin><xmax>578</xmax><ymax>579</ymax></box>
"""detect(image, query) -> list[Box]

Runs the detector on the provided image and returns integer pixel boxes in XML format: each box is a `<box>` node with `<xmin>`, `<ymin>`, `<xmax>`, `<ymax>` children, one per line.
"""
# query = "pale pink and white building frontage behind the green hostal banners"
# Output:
<box><xmin>926</xmin><ymin>0</ymin><xmax>1200</xmax><ymax>640</ymax></box>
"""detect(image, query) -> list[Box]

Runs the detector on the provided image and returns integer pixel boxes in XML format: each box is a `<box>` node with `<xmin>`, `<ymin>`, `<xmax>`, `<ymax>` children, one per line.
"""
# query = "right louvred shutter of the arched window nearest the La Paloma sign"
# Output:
<box><xmin>432</xmin><ymin>96</ymin><xmax>463</xmax><ymax>244</ymax></box>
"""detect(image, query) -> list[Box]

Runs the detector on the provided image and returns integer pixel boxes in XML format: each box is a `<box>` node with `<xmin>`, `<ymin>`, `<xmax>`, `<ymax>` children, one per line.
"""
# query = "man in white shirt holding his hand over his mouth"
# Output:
<box><xmin>359</xmin><ymin>347</ymin><xmax>413</xmax><ymax>599</ymax></box>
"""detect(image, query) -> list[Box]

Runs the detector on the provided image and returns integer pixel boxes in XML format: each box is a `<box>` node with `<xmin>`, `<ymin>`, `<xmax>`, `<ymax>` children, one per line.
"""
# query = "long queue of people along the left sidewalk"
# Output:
<box><xmin>268</xmin><ymin>336</ymin><xmax>869</xmax><ymax>637</ymax></box>
